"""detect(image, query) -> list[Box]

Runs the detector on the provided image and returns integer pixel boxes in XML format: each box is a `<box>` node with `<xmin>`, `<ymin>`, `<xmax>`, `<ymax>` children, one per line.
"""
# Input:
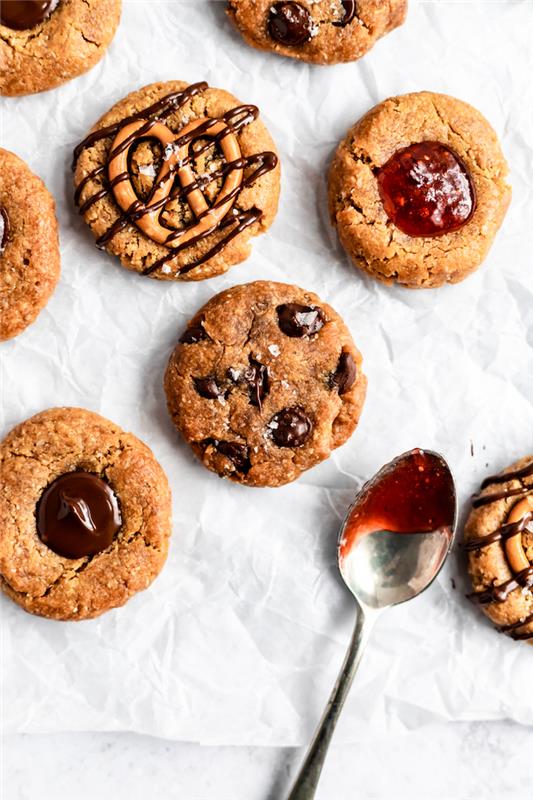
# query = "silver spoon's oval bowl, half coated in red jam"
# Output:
<box><xmin>338</xmin><ymin>450</ymin><xmax>457</xmax><ymax>609</ymax></box>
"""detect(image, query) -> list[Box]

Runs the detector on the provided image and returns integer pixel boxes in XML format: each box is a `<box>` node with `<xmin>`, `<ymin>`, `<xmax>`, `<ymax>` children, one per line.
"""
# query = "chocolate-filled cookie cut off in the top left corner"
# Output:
<box><xmin>0</xmin><ymin>0</ymin><xmax>121</xmax><ymax>96</ymax></box>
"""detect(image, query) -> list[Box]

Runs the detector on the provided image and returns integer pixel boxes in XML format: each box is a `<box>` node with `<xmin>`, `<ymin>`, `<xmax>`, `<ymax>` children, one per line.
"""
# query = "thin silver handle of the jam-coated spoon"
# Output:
<box><xmin>288</xmin><ymin>606</ymin><xmax>378</xmax><ymax>800</ymax></box>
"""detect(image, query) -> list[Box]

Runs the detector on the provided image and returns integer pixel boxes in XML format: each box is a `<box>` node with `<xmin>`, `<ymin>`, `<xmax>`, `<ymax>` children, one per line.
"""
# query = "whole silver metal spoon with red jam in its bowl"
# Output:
<box><xmin>288</xmin><ymin>450</ymin><xmax>457</xmax><ymax>800</ymax></box>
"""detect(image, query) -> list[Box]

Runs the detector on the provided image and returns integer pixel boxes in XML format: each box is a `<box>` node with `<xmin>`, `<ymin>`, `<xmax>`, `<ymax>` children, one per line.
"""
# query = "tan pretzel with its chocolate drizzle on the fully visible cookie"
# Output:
<box><xmin>74</xmin><ymin>83</ymin><xmax>277</xmax><ymax>275</ymax></box>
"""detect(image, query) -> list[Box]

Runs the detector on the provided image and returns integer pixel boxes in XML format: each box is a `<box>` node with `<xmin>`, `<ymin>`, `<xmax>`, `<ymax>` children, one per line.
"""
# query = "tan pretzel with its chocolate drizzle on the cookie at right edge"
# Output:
<box><xmin>463</xmin><ymin>463</ymin><xmax>533</xmax><ymax>640</ymax></box>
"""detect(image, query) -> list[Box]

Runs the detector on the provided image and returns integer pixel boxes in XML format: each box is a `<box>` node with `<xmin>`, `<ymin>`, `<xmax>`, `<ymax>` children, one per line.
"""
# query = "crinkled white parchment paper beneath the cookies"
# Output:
<box><xmin>0</xmin><ymin>0</ymin><xmax>533</xmax><ymax>745</ymax></box>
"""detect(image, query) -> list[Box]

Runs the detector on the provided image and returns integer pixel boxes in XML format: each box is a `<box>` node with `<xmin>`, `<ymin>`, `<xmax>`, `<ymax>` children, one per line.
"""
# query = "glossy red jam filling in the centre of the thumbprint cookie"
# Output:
<box><xmin>377</xmin><ymin>142</ymin><xmax>476</xmax><ymax>236</ymax></box>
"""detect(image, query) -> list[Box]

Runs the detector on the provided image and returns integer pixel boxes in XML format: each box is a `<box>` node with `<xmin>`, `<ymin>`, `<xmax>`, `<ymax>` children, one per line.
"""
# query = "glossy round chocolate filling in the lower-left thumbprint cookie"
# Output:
<box><xmin>37</xmin><ymin>472</ymin><xmax>122</xmax><ymax>558</ymax></box>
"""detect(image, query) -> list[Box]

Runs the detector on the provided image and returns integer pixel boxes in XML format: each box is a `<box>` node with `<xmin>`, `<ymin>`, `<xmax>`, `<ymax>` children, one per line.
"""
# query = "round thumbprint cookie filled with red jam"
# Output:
<box><xmin>329</xmin><ymin>92</ymin><xmax>511</xmax><ymax>288</ymax></box>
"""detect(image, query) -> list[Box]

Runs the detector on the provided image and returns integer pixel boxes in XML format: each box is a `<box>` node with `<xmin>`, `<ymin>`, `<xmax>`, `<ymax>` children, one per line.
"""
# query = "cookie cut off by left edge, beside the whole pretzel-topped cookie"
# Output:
<box><xmin>0</xmin><ymin>148</ymin><xmax>60</xmax><ymax>341</ymax></box>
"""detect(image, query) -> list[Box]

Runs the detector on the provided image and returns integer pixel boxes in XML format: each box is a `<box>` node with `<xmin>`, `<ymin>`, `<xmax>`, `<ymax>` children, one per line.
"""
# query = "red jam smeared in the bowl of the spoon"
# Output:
<box><xmin>340</xmin><ymin>450</ymin><xmax>455</xmax><ymax>558</ymax></box>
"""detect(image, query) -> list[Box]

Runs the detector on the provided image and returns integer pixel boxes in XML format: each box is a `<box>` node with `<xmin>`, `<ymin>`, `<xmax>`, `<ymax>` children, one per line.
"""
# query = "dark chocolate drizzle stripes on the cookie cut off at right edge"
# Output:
<box><xmin>463</xmin><ymin>463</ymin><xmax>533</xmax><ymax>640</ymax></box>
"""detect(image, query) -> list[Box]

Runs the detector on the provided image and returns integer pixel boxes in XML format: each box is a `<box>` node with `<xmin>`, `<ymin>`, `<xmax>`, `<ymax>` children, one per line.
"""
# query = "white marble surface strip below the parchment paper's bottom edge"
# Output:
<box><xmin>0</xmin><ymin>722</ymin><xmax>533</xmax><ymax>800</ymax></box>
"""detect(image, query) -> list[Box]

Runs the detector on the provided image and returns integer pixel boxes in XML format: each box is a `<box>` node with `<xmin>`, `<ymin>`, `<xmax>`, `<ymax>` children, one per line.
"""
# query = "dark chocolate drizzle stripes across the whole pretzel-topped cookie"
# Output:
<box><xmin>73</xmin><ymin>82</ymin><xmax>278</xmax><ymax>275</ymax></box>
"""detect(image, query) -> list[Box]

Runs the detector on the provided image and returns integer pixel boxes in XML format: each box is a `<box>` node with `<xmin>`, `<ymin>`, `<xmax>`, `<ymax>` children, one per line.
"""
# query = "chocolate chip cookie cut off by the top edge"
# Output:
<box><xmin>227</xmin><ymin>0</ymin><xmax>407</xmax><ymax>64</ymax></box>
